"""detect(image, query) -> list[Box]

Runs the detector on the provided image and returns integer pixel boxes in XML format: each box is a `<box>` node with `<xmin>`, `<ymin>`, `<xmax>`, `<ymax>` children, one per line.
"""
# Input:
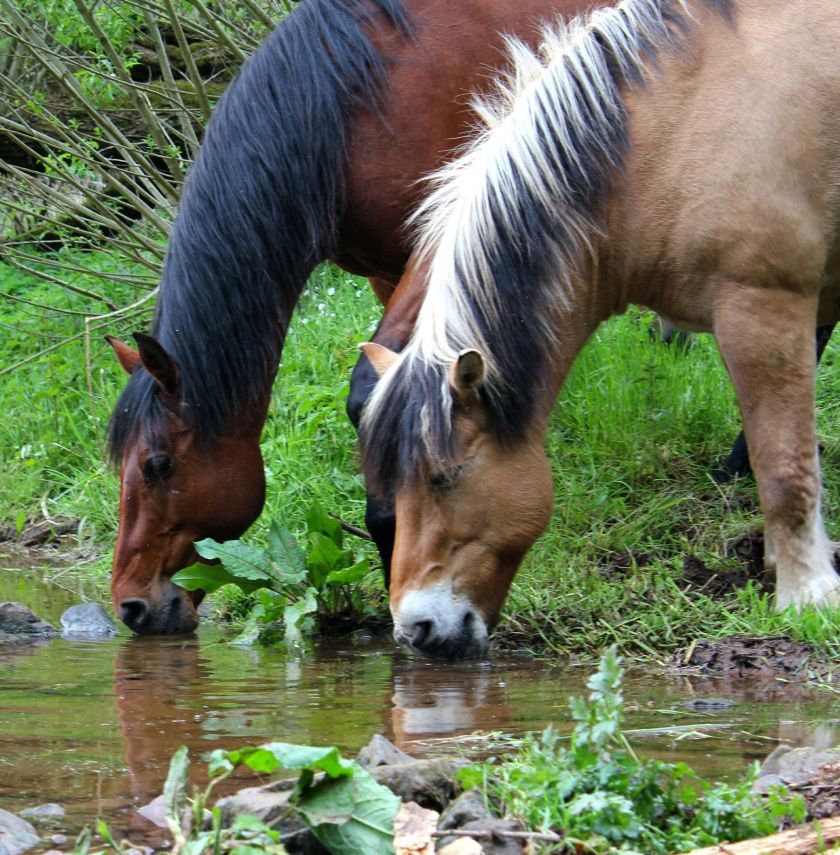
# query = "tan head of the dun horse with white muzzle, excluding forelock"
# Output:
<box><xmin>364</xmin><ymin>344</ymin><xmax>553</xmax><ymax>659</ymax></box>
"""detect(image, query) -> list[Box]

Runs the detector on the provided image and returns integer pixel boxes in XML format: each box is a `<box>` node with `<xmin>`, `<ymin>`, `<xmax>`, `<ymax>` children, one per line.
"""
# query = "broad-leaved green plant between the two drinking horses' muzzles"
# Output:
<box><xmin>172</xmin><ymin>504</ymin><xmax>376</xmax><ymax>644</ymax></box>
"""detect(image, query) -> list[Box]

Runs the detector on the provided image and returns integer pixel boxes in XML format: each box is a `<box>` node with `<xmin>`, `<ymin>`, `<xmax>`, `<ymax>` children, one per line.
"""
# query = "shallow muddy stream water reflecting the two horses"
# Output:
<box><xmin>0</xmin><ymin>570</ymin><xmax>840</xmax><ymax>838</ymax></box>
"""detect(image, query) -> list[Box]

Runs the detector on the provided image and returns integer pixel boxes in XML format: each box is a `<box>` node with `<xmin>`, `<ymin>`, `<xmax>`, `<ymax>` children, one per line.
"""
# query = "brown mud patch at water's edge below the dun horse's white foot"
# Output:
<box><xmin>672</xmin><ymin>636</ymin><xmax>828</xmax><ymax>680</ymax></box>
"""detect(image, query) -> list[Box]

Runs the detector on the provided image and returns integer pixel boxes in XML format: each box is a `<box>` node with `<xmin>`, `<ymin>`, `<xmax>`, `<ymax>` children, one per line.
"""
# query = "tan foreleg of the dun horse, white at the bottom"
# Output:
<box><xmin>714</xmin><ymin>285</ymin><xmax>840</xmax><ymax>609</ymax></box>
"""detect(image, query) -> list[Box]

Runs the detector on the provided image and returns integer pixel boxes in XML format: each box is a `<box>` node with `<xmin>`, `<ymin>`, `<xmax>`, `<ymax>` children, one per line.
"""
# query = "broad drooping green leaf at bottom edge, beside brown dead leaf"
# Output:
<box><xmin>296</xmin><ymin>767</ymin><xmax>400</xmax><ymax>855</ymax></box>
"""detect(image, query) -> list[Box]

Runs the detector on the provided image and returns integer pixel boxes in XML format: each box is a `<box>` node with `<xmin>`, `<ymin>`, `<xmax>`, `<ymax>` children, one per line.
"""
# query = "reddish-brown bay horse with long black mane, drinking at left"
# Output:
<box><xmin>108</xmin><ymin>0</ymin><xmax>604</xmax><ymax>634</ymax></box>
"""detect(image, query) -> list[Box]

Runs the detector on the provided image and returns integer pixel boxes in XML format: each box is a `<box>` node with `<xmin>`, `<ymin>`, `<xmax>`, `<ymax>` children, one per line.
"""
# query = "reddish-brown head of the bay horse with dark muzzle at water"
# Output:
<box><xmin>107</xmin><ymin>333</ymin><xmax>265</xmax><ymax>635</ymax></box>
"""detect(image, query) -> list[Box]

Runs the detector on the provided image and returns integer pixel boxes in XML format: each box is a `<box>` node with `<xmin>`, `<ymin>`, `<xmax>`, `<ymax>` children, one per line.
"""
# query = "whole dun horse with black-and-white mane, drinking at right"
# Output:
<box><xmin>361</xmin><ymin>0</ymin><xmax>840</xmax><ymax>658</ymax></box>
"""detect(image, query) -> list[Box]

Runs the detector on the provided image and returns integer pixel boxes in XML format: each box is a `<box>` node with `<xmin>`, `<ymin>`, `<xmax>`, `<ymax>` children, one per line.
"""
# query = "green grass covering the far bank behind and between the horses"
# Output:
<box><xmin>0</xmin><ymin>251</ymin><xmax>840</xmax><ymax>656</ymax></box>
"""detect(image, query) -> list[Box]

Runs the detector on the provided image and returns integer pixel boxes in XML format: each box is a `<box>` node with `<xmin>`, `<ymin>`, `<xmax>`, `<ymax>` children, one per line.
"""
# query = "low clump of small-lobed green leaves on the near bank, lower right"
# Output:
<box><xmin>462</xmin><ymin>648</ymin><xmax>805</xmax><ymax>855</ymax></box>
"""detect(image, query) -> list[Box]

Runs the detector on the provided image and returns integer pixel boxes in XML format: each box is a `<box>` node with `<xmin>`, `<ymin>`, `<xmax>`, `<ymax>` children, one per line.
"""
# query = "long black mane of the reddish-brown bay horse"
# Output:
<box><xmin>108</xmin><ymin>0</ymin><xmax>410</xmax><ymax>462</ymax></box>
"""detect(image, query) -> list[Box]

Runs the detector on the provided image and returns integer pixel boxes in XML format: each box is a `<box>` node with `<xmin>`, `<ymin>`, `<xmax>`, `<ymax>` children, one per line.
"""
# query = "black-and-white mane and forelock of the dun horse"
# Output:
<box><xmin>362</xmin><ymin>0</ymin><xmax>732</xmax><ymax>491</ymax></box>
